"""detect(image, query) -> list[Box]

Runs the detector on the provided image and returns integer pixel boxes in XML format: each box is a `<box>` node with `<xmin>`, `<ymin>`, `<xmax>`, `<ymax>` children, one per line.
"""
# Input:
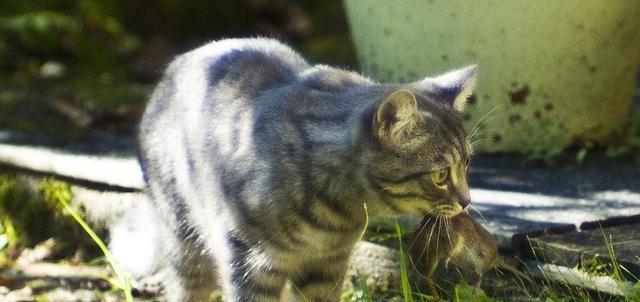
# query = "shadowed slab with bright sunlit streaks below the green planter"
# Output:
<box><xmin>469</xmin><ymin>155</ymin><xmax>640</xmax><ymax>247</ymax></box>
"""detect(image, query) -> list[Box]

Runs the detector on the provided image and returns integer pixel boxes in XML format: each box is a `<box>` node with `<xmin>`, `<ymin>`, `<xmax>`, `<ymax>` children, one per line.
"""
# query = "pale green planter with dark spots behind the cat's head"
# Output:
<box><xmin>345</xmin><ymin>0</ymin><xmax>640</xmax><ymax>152</ymax></box>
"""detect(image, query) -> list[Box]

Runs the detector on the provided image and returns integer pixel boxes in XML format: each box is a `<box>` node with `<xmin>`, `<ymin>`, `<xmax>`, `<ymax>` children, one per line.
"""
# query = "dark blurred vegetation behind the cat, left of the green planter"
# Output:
<box><xmin>0</xmin><ymin>0</ymin><xmax>355</xmax><ymax>139</ymax></box>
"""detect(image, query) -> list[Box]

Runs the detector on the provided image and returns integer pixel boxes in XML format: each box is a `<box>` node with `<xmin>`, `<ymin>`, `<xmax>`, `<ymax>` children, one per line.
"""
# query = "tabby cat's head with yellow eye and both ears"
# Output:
<box><xmin>369</xmin><ymin>66</ymin><xmax>476</xmax><ymax>217</ymax></box>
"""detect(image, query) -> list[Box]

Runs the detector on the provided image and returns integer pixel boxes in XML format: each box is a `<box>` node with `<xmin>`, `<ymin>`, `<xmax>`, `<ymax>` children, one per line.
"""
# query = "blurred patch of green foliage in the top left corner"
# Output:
<box><xmin>0</xmin><ymin>0</ymin><xmax>139</xmax><ymax>68</ymax></box>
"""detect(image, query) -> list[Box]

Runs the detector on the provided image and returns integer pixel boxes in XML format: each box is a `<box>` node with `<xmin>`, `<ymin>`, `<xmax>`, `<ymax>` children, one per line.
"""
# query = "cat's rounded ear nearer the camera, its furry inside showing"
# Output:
<box><xmin>373</xmin><ymin>90</ymin><xmax>422</xmax><ymax>146</ymax></box>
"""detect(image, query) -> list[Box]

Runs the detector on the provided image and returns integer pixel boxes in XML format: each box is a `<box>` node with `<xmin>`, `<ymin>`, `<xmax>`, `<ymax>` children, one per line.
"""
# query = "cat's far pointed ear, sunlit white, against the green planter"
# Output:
<box><xmin>423</xmin><ymin>65</ymin><xmax>478</xmax><ymax>111</ymax></box>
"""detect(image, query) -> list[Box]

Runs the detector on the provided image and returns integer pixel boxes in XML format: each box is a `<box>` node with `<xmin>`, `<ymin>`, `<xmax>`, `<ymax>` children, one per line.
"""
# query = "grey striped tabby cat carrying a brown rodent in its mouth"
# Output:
<box><xmin>120</xmin><ymin>38</ymin><xmax>475</xmax><ymax>302</ymax></box>
